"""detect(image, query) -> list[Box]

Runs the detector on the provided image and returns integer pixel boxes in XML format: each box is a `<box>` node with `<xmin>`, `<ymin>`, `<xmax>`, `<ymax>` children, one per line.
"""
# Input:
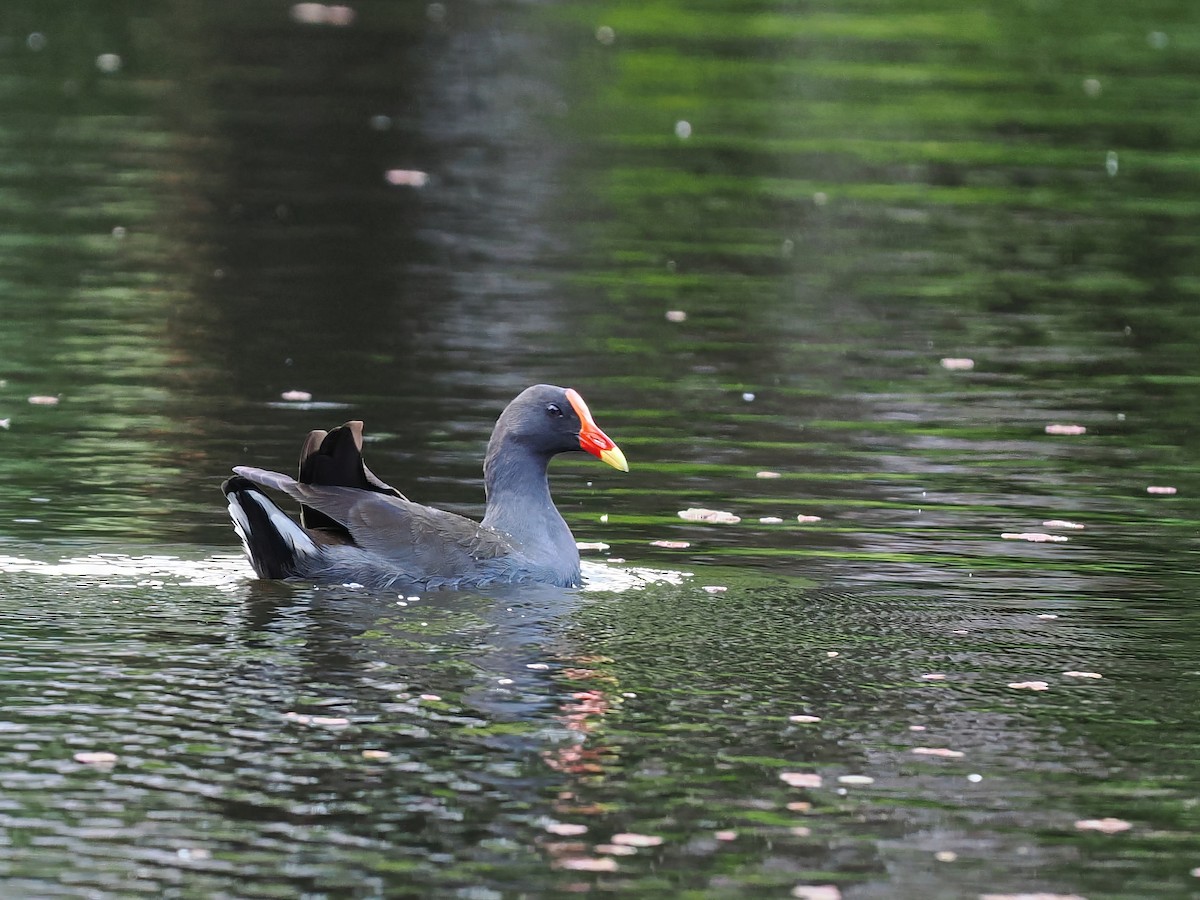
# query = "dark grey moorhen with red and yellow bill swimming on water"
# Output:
<box><xmin>221</xmin><ymin>384</ymin><xmax>629</xmax><ymax>592</ymax></box>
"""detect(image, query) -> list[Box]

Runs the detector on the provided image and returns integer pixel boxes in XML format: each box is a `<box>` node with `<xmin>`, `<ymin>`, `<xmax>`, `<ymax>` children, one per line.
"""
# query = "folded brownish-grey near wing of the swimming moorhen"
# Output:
<box><xmin>234</xmin><ymin>466</ymin><xmax>517</xmax><ymax>582</ymax></box>
